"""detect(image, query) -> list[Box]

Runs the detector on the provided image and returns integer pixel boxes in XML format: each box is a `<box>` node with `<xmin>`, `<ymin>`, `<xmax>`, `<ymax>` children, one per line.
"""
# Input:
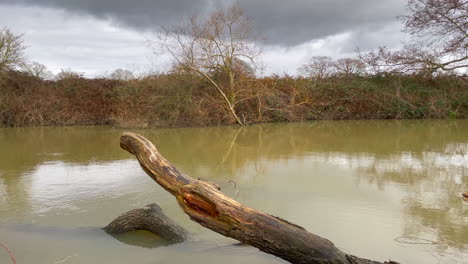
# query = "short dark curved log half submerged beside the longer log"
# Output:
<box><xmin>103</xmin><ymin>203</ymin><xmax>191</xmax><ymax>243</ymax></box>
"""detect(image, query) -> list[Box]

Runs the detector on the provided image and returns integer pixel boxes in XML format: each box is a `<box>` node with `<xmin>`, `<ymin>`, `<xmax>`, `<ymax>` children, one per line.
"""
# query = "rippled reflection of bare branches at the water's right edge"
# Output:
<box><xmin>398</xmin><ymin>147</ymin><xmax>468</xmax><ymax>251</ymax></box>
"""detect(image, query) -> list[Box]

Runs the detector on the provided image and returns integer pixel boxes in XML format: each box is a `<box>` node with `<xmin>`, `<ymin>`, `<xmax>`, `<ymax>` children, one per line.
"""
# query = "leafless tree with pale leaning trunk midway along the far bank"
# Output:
<box><xmin>149</xmin><ymin>5</ymin><xmax>260</xmax><ymax>125</ymax></box>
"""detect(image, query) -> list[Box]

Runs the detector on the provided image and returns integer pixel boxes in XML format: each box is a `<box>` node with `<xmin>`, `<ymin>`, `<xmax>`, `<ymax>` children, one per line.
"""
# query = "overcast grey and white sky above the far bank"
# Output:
<box><xmin>0</xmin><ymin>0</ymin><xmax>405</xmax><ymax>77</ymax></box>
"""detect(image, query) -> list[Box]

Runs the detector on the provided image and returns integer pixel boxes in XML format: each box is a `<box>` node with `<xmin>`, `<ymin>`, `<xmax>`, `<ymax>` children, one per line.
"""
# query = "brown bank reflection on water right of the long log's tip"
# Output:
<box><xmin>122</xmin><ymin>120</ymin><xmax>468</xmax><ymax>182</ymax></box>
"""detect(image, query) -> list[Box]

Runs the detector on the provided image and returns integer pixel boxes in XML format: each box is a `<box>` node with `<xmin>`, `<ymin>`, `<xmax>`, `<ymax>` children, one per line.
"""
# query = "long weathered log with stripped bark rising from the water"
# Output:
<box><xmin>120</xmin><ymin>133</ymin><xmax>396</xmax><ymax>264</ymax></box>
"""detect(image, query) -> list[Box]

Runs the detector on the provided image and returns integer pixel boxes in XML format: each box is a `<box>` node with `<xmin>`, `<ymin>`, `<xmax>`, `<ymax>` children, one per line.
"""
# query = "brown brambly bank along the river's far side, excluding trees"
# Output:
<box><xmin>0</xmin><ymin>72</ymin><xmax>468</xmax><ymax>127</ymax></box>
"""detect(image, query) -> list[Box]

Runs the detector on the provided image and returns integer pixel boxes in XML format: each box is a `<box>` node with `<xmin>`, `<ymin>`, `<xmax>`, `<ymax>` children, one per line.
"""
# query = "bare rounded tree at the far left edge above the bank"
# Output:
<box><xmin>0</xmin><ymin>28</ymin><xmax>26</xmax><ymax>72</ymax></box>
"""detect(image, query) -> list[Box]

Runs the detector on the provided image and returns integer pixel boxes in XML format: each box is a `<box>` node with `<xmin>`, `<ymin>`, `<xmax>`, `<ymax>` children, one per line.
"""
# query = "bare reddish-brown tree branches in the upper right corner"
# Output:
<box><xmin>361</xmin><ymin>0</ymin><xmax>468</xmax><ymax>74</ymax></box>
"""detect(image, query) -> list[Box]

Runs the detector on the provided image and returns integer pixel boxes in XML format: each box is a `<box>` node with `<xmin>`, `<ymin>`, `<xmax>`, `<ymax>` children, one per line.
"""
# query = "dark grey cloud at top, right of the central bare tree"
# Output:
<box><xmin>242</xmin><ymin>0</ymin><xmax>404</xmax><ymax>45</ymax></box>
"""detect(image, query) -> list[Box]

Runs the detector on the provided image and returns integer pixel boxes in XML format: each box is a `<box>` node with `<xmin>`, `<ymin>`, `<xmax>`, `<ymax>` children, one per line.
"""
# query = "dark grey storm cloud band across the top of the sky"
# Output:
<box><xmin>0</xmin><ymin>0</ymin><xmax>405</xmax><ymax>46</ymax></box>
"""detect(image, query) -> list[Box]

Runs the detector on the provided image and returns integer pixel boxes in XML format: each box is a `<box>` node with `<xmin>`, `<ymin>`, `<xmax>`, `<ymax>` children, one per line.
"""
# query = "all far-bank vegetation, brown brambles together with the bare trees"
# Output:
<box><xmin>0</xmin><ymin>0</ymin><xmax>468</xmax><ymax>127</ymax></box>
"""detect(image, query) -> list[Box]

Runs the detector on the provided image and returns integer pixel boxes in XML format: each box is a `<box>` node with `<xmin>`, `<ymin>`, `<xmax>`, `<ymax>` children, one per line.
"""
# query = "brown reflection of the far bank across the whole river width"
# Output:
<box><xmin>0</xmin><ymin>120</ymin><xmax>468</xmax><ymax>176</ymax></box>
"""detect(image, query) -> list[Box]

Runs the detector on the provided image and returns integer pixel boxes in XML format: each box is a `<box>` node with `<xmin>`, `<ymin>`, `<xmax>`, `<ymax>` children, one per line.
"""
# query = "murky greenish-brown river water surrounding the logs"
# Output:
<box><xmin>0</xmin><ymin>120</ymin><xmax>468</xmax><ymax>263</ymax></box>
